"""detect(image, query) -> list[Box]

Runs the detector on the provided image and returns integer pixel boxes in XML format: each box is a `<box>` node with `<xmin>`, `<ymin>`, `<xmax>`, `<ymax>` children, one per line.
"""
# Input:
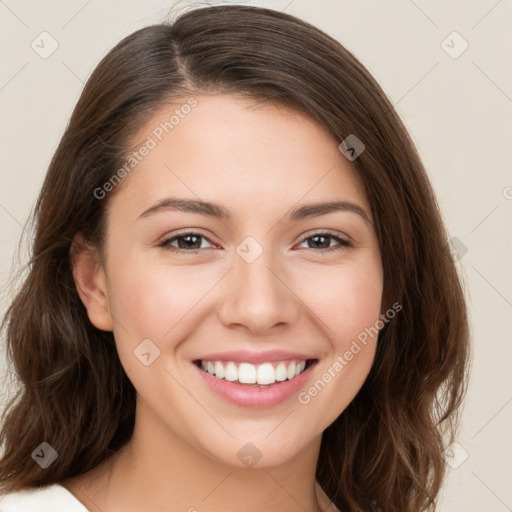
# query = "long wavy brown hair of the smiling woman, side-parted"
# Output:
<box><xmin>0</xmin><ymin>5</ymin><xmax>469</xmax><ymax>512</ymax></box>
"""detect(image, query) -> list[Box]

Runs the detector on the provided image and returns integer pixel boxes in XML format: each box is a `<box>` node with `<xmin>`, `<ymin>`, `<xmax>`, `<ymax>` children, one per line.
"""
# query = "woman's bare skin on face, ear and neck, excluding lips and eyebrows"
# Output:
<box><xmin>63</xmin><ymin>95</ymin><xmax>384</xmax><ymax>512</ymax></box>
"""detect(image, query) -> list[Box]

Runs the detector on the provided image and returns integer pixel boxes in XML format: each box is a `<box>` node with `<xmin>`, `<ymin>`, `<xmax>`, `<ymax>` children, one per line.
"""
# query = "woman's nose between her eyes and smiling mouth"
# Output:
<box><xmin>217</xmin><ymin>242</ymin><xmax>301</xmax><ymax>335</ymax></box>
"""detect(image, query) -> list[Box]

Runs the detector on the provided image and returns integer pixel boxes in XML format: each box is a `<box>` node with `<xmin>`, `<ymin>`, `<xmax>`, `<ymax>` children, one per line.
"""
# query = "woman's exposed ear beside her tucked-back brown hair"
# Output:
<box><xmin>70</xmin><ymin>233</ymin><xmax>113</xmax><ymax>331</ymax></box>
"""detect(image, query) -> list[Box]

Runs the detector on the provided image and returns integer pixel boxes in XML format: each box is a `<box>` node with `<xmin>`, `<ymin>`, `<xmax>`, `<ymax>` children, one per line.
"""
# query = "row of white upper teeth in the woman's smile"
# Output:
<box><xmin>201</xmin><ymin>360</ymin><xmax>306</xmax><ymax>385</ymax></box>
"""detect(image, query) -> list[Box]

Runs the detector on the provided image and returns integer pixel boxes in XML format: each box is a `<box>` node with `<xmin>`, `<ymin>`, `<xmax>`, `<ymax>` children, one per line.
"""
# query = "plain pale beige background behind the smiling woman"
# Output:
<box><xmin>0</xmin><ymin>0</ymin><xmax>512</xmax><ymax>512</ymax></box>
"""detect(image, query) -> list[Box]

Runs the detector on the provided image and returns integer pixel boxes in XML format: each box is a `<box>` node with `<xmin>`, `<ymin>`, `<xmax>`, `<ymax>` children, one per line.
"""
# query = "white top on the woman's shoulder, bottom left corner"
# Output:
<box><xmin>0</xmin><ymin>484</ymin><xmax>89</xmax><ymax>512</ymax></box>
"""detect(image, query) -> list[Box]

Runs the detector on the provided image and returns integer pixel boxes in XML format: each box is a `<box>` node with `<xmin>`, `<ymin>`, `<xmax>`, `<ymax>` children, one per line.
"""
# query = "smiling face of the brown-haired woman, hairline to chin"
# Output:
<box><xmin>76</xmin><ymin>95</ymin><xmax>383</xmax><ymax>467</ymax></box>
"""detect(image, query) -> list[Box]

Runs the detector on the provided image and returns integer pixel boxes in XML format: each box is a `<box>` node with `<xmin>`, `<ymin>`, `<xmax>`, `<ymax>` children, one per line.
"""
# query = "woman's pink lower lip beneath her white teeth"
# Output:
<box><xmin>192</xmin><ymin>361</ymin><xmax>318</xmax><ymax>408</ymax></box>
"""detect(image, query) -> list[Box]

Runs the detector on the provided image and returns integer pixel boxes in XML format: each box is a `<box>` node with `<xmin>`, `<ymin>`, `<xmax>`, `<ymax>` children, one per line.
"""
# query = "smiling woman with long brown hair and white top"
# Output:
<box><xmin>0</xmin><ymin>6</ymin><xmax>468</xmax><ymax>512</ymax></box>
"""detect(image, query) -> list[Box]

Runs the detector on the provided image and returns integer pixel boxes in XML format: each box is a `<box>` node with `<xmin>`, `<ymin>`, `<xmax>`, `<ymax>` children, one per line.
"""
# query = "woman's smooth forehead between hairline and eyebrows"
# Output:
<box><xmin>113</xmin><ymin>95</ymin><xmax>370</xmax><ymax>220</ymax></box>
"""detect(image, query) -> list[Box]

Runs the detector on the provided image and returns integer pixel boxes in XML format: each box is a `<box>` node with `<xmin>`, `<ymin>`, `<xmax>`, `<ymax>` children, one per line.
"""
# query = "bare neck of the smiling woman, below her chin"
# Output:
<box><xmin>65</xmin><ymin>404</ymin><xmax>336</xmax><ymax>512</ymax></box>
